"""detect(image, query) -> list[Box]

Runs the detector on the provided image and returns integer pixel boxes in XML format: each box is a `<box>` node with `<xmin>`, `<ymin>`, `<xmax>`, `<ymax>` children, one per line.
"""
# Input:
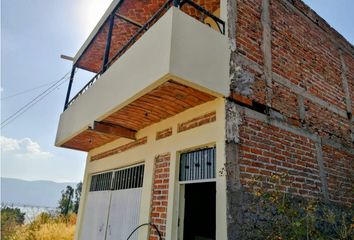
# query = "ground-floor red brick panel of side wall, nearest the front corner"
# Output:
<box><xmin>239</xmin><ymin>117</ymin><xmax>321</xmax><ymax>197</ymax></box>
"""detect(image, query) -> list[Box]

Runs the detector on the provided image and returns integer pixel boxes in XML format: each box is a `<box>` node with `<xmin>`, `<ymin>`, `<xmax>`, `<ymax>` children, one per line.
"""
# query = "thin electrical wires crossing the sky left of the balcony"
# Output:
<box><xmin>1</xmin><ymin>72</ymin><xmax>70</xmax><ymax>128</ymax></box>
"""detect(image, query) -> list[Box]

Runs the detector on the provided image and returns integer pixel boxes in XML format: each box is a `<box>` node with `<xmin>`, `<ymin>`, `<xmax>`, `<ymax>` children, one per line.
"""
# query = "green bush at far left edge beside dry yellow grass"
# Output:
<box><xmin>1</xmin><ymin>207</ymin><xmax>25</xmax><ymax>240</ymax></box>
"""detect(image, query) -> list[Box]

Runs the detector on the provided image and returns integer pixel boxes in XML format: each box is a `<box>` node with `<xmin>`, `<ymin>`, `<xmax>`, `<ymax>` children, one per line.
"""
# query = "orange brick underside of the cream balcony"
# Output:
<box><xmin>62</xmin><ymin>80</ymin><xmax>215</xmax><ymax>151</ymax></box>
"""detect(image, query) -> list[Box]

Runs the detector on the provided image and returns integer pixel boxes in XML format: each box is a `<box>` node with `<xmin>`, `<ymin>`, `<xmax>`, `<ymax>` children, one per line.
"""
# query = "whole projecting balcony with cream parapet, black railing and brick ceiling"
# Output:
<box><xmin>56</xmin><ymin>0</ymin><xmax>229</xmax><ymax>151</ymax></box>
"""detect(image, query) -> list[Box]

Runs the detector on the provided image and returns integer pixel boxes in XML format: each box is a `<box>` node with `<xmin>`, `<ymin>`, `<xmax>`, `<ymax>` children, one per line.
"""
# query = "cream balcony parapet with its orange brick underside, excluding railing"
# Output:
<box><xmin>55</xmin><ymin>7</ymin><xmax>230</xmax><ymax>151</ymax></box>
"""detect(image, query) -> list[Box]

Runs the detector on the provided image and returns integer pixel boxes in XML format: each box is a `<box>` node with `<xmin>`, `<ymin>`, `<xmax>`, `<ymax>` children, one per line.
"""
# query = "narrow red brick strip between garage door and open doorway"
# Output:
<box><xmin>149</xmin><ymin>153</ymin><xmax>170</xmax><ymax>240</ymax></box>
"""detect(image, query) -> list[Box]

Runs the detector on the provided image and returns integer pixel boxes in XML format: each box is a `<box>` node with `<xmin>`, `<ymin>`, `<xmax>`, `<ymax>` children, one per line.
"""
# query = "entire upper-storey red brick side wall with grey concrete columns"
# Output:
<box><xmin>229</xmin><ymin>0</ymin><xmax>354</xmax><ymax>144</ymax></box>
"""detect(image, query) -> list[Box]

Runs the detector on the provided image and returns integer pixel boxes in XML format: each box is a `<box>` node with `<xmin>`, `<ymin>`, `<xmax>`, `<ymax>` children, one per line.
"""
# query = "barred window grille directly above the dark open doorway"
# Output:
<box><xmin>179</xmin><ymin>147</ymin><xmax>216</xmax><ymax>181</ymax></box>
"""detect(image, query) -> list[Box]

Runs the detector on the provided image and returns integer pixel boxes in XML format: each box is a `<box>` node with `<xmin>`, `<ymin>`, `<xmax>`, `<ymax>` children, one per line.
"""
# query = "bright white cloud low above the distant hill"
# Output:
<box><xmin>0</xmin><ymin>136</ymin><xmax>53</xmax><ymax>159</ymax></box>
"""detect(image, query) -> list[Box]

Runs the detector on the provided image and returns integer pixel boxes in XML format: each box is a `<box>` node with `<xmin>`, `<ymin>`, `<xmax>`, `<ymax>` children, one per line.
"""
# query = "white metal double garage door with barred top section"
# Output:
<box><xmin>80</xmin><ymin>165</ymin><xmax>144</xmax><ymax>240</ymax></box>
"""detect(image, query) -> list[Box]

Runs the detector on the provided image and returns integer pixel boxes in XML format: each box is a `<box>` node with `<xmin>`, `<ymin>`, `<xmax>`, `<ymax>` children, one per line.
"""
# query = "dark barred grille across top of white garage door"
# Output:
<box><xmin>90</xmin><ymin>165</ymin><xmax>144</xmax><ymax>192</ymax></box>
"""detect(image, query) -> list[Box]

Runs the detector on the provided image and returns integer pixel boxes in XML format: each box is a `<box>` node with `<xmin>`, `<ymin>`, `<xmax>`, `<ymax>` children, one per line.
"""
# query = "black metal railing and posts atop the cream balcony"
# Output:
<box><xmin>64</xmin><ymin>0</ymin><xmax>225</xmax><ymax>111</ymax></box>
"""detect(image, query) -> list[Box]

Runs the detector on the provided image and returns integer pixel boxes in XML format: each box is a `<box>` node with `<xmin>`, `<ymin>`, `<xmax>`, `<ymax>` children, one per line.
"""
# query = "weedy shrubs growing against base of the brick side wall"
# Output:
<box><xmin>236</xmin><ymin>174</ymin><xmax>354</xmax><ymax>240</ymax></box>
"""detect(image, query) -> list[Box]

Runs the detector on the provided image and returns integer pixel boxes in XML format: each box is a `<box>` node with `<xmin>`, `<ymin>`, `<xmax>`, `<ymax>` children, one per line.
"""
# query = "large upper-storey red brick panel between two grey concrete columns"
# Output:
<box><xmin>270</xmin><ymin>1</ymin><xmax>345</xmax><ymax>110</ymax></box>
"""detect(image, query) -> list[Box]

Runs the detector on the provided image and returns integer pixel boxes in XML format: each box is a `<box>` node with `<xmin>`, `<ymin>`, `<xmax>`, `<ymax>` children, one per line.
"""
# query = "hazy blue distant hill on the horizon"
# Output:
<box><xmin>1</xmin><ymin>178</ymin><xmax>76</xmax><ymax>207</ymax></box>
